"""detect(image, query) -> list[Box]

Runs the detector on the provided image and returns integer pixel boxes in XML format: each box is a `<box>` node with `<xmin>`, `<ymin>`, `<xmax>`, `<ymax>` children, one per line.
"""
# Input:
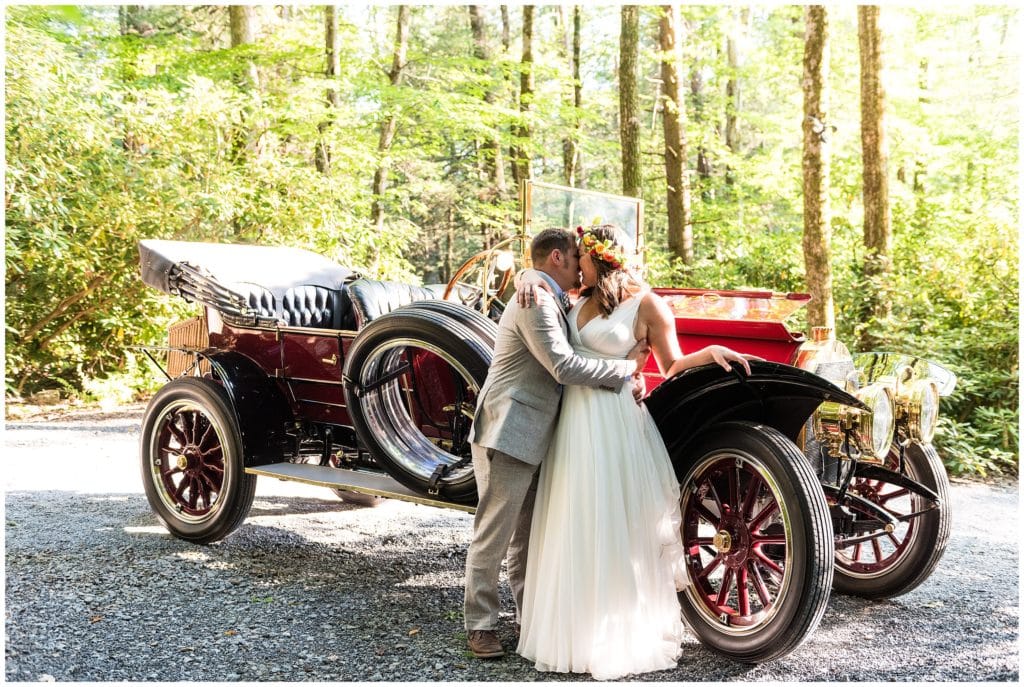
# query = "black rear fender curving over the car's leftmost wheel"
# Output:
<box><xmin>199</xmin><ymin>349</ymin><xmax>295</xmax><ymax>467</ymax></box>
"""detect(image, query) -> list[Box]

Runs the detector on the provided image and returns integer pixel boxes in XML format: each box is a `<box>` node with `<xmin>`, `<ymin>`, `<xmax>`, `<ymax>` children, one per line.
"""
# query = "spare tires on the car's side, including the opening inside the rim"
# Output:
<box><xmin>344</xmin><ymin>304</ymin><xmax>493</xmax><ymax>504</ymax></box>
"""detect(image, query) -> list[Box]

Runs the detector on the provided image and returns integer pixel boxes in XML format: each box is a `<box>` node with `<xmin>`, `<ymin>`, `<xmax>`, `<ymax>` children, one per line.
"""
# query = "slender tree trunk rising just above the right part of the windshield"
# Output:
<box><xmin>618</xmin><ymin>5</ymin><xmax>643</xmax><ymax>198</ymax></box>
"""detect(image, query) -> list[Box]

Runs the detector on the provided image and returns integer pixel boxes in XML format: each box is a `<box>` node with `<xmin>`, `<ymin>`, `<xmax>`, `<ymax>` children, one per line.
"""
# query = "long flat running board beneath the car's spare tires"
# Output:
<box><xmin>246</xmin><ymin>463</ymin><xmax>476</xmax><ymax>513</ymax></box>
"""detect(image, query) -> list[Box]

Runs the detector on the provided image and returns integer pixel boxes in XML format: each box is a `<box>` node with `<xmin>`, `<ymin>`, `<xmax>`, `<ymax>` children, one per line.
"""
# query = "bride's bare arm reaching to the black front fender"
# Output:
<box><xmin>635</xmin><ymin>292</ymin><xmax>762</xmax><ymax>378</ymax></box>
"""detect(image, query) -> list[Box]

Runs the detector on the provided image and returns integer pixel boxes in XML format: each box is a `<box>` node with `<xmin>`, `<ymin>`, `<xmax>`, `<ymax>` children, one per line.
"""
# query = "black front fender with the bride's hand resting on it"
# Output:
<box><xmin>644</xmin><ymin>361</ymin><xmax>866</xmax><ymax>462</ymax></box>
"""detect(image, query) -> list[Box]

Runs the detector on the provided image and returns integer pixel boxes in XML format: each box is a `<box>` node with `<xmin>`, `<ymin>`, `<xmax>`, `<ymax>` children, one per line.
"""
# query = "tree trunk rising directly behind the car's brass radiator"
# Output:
<box><xmin>803</xmin><ymin>5</ymin><xmax>836</xmax><ymax>328</ymax></box>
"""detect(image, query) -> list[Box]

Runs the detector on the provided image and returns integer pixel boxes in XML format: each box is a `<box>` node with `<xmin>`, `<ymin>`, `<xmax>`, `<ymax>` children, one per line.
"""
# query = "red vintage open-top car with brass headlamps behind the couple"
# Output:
<box><xmin>139</xmin><ymin>183</ymin><xmax>955</xmax><ymax>662</ymax></box>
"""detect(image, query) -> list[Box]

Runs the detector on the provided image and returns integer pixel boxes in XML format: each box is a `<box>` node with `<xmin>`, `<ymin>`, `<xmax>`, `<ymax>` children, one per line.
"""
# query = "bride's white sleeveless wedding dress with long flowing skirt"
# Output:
<box><xmin>517</xmin><ymin>297</ymin><xmax>684</xmax><ymax>680</ymax></box>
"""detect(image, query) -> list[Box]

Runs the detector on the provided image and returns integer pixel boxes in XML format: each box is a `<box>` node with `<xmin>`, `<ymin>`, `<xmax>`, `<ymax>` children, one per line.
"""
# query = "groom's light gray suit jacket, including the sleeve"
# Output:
<box><xmin>469</xmin><ymin>294</ymin><xmax>636</xmax><ymax>465</ymax></box>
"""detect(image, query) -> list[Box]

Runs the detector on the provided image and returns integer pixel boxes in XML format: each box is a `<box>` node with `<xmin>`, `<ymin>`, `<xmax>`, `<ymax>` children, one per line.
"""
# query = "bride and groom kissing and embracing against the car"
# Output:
<box><xmin>464</xmin><ymin>224</ymin><xmax>752</xmax><ymax>680</ymax></box>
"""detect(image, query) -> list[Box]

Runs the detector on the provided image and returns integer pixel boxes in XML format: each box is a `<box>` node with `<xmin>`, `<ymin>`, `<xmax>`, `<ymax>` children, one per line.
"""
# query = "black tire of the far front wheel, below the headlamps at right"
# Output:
<box><xmin>833</xmin><ymin>443</ymin><xmax>952</xmax><ymax>599</ymax></box>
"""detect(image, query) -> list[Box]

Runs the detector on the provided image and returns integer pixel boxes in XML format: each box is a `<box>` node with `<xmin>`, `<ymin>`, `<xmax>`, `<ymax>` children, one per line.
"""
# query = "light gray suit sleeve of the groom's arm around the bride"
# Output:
<box><xmin>512</xmin><ymin>297</ymin><xmax>637</xmax><ymax>391</ymax></box>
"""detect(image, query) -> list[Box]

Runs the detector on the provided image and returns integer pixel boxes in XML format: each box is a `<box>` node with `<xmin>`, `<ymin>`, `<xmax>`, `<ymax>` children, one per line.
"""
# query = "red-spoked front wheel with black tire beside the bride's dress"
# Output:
<box><xmin>673</xmin><ymin>422</ymin><xmax>833</xmax><ymax>663</ymax></box>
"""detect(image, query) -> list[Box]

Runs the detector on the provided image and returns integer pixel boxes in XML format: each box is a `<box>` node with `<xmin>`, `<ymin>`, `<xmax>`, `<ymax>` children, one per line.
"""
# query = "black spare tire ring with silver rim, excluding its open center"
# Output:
<box><xmin>344</xmin><ymin>306</ymin><xmax>493</xmax><ymax>504</ymax></box>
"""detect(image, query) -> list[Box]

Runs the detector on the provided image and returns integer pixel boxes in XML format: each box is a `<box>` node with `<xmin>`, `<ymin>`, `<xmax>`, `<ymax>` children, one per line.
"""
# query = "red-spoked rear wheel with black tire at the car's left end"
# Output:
<box><xmin>139</xmin><ymin>377</ymin><xmax>256</xmax><ymax>544</ymax></box>
